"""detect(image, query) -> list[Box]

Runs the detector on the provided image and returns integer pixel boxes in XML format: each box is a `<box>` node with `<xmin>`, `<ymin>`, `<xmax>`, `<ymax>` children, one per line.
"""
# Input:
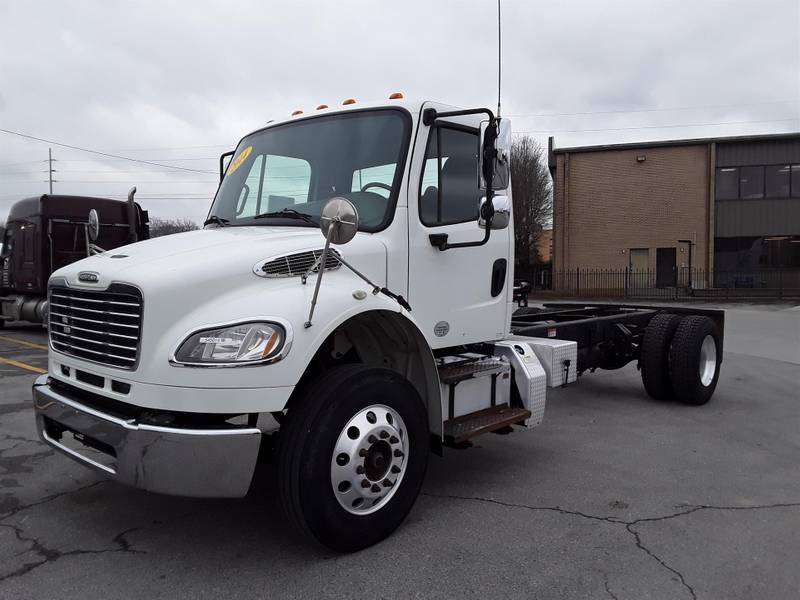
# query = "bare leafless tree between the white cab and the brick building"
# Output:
<box><xmin>511</xmin><ymin>136</ymin><xmax>553</xmax><ymax>270</ymax></box>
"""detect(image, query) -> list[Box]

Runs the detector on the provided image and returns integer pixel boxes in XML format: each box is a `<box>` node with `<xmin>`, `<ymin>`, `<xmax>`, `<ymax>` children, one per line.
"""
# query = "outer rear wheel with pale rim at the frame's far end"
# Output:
<box><xmin>669</xmin><ymin>315</ymin><xmax>722</xmax><ymax>405</ymax></box>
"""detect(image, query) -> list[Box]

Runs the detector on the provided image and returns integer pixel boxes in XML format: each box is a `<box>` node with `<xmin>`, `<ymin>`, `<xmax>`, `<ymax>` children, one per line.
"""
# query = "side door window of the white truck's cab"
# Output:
<box><xmin>419</xmin><ymin>127</ymin><xmax>481</xmax><ymax>227</ymax></box>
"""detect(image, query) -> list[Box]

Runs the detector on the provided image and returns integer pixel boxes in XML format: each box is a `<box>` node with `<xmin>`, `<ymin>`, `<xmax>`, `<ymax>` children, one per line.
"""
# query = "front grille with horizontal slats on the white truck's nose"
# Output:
<box><xmin>49</xmin><ymin>283</ymin><xmax>143</xmax><ymax>369</ymax></box>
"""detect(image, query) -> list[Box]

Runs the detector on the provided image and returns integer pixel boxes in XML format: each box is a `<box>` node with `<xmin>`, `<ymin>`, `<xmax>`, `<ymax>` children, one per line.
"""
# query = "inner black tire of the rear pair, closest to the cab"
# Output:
<box><xmin>639</xmin><ymin>313</ymin><xmax>681</xmax><ymax>400</ymax></box>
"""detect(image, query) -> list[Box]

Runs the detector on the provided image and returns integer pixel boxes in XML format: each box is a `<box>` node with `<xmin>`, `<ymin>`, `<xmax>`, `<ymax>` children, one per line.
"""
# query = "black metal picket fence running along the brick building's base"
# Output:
<box><xmin>515</xmin><ymin>268</ymin><xmax>800</xmax><ymax>300</ymax></box>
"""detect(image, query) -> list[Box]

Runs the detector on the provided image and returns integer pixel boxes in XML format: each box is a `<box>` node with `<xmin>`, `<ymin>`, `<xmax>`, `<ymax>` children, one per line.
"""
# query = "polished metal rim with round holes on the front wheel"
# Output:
<box><xmin>331</xmin><ymin>404</ymin><xmax>408</xmax><ymax>515</ymax></box>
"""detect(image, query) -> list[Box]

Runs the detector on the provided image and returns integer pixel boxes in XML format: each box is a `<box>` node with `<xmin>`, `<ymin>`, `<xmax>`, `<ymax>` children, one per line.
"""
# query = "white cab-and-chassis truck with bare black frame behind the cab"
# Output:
<box><xmin>33</xmin><ymin>95</ymin><xmax>724</xmax><ymax>551</ymax></box>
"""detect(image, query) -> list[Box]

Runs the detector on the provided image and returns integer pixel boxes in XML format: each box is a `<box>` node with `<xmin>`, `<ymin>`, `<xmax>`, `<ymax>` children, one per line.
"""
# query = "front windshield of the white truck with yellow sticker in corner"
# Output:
<box><xmin>209</xmin><ymin>109</ymin><xmax>410</xmax><ymax>231</ymax></box>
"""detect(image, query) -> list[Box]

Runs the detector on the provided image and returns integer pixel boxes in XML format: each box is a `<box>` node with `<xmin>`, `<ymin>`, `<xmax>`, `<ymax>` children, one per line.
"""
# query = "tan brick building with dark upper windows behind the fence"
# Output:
<box><xmin>549</xmin><ymin>134</ymin><xmax>800</xmax><ymax>285</ymax></box>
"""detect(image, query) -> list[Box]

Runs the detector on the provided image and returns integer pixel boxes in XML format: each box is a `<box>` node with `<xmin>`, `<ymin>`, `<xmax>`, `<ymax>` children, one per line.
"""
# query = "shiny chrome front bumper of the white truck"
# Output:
<box><xmin>33</xmin><ymin>375</ymin><xmax>261</xmax><ymax>498</ymax></box>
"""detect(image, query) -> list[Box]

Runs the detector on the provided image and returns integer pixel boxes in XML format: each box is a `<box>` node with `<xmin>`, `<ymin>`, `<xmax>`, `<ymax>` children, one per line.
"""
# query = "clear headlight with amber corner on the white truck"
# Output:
<box><xmin>172</xmin><ymin>323</ymin><xmax>289</xmax><ymax>366</ymax></box>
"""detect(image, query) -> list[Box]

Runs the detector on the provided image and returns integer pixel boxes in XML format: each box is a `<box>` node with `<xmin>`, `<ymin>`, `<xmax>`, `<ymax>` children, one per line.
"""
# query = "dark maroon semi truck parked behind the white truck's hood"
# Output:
<box><xmin>0</xmin><ymin>188</ymin><xmax>149</xmax><ymax>327</ymax></box>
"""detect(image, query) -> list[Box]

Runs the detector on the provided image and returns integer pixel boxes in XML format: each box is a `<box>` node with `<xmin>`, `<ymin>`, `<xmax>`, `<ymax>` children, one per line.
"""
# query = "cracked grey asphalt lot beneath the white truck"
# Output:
<box><xmin>0</xmin><ymin>306</ymin><xmax>800</xmax><ymax>600</ymax></box>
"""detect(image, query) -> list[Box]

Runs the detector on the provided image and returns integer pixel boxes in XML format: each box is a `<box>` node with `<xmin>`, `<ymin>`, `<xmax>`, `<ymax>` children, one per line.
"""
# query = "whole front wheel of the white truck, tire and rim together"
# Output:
<box><xmin>278</xmin><ymin>365</ymin><xmax>429</xmax><ymax>552</ymax></box>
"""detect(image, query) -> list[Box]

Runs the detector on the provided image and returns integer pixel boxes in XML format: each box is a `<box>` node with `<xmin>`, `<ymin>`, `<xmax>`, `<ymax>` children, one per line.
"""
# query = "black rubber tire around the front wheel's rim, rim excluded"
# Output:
<box><xmin>278</xmin><ymin>365</ymin><xmax>429</xmax><ymax>552</ymax></box>
